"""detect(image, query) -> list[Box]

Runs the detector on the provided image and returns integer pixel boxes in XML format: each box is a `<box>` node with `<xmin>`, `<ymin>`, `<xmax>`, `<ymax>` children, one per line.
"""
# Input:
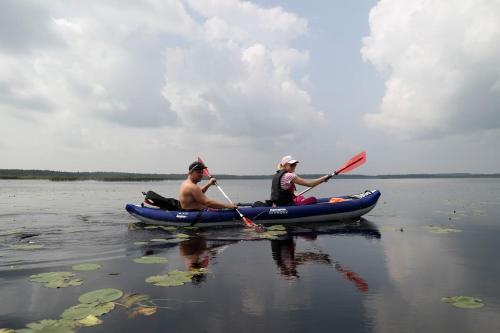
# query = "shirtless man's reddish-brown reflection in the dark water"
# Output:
<box><xmin>179</xmin><ymin>237</ymin><xmax>235</xmax><ymax>283</ymax></box>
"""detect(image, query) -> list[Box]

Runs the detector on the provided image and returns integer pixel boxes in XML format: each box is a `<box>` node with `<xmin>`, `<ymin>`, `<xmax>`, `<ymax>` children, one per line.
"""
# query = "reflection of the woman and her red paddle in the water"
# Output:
<box><xmin>271</xmin><ymin>236</ymin><xmax>368</xmax><ymax>292</ymax></box>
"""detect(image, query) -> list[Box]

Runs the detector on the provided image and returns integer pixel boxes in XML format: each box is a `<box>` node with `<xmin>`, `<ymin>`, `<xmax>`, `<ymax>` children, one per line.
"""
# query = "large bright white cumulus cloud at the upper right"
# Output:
<box><xmin>361</xmin><ymin>0</ymin><xmax>500</xmax><ymax>137</ymax></box>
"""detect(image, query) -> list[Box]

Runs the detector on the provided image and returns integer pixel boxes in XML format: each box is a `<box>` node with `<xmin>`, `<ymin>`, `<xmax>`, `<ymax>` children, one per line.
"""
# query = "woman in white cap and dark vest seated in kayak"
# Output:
<box><xmin>271</xmin><ymin>155</ymin><xmax>331</xmax><ymax>206</ymax></box>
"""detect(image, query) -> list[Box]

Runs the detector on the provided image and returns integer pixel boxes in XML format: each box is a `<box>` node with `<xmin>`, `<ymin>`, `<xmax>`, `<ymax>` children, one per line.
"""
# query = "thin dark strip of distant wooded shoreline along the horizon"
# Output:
<box><xmin>0</xmin><ymin>169</ymin><xmax>500</xmax><ymax>182</ymax></box>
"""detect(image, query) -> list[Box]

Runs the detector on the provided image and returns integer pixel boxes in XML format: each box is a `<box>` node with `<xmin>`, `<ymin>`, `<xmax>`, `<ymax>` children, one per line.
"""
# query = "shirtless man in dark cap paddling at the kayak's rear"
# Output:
<box><xmin>179</xmin><ymin>162</ymin><xmax>237</xmax><ymax>210</ymax></box>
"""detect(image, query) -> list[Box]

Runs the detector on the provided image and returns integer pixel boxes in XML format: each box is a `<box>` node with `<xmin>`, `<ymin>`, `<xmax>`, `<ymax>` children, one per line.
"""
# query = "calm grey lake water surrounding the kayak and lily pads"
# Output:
<box><xmin>0</xmin><ymin>179</ymin><xmax>500</xmax><ymax>332</ymax></box>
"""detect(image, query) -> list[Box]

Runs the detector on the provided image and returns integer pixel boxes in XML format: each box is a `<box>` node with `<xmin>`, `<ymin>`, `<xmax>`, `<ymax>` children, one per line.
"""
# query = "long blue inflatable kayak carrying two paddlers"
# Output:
<box><xmin>125</xmin><ymin>190</ymin><xmax>380</xmax><ymax>227</ymax></box>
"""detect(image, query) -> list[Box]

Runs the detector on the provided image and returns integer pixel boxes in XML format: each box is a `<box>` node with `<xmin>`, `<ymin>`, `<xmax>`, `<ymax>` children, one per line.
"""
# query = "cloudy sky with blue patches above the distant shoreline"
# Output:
<box><xmin>0</xmin><ymin>0</ymin><xmax>500</xmax><ymax>175</ymax></box>
